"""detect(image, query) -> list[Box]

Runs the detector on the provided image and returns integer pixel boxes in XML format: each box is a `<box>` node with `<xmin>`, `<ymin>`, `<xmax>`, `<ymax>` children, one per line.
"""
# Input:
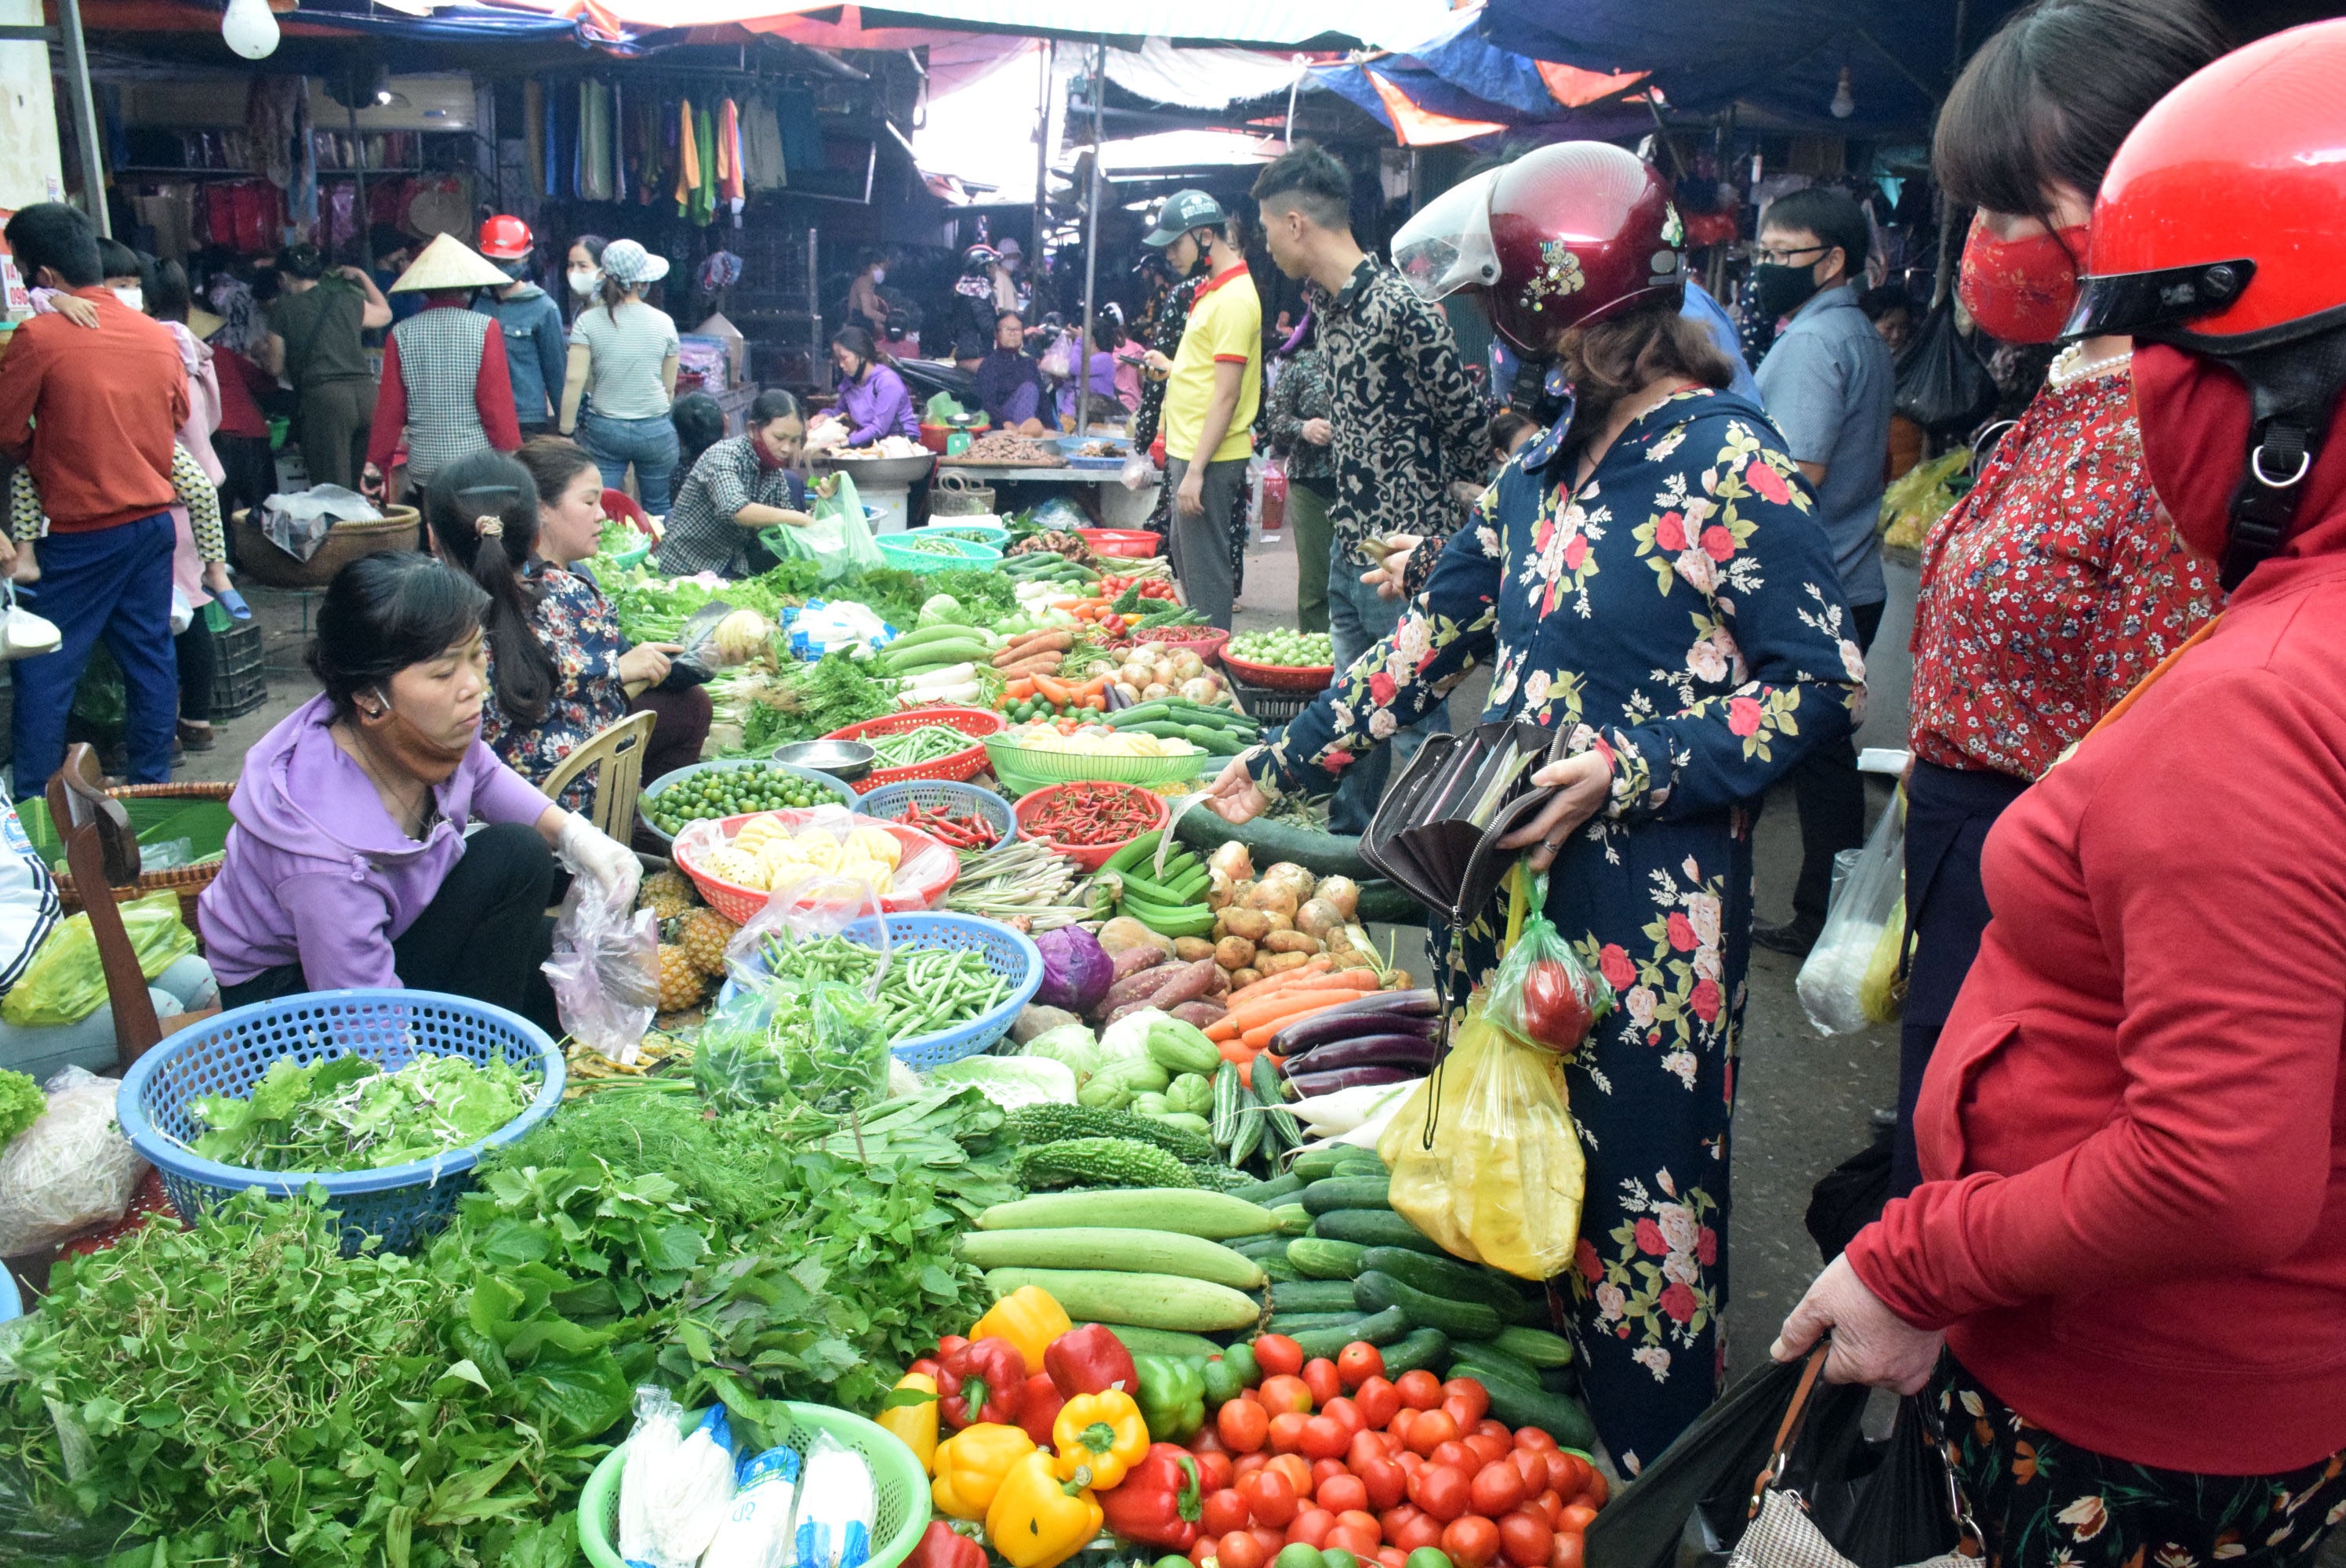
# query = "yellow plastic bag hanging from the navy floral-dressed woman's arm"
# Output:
<box><xmin>1377</xmin><ymin>871</ymin><xmax>1589</xmax><ymax>1279</ymax></box>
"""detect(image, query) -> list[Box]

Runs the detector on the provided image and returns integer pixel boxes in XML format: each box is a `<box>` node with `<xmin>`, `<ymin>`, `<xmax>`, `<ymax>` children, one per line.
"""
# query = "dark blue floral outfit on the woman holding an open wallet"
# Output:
<box><xmin>1251</xmin><ymin>390</ymin><xmax>1865</xmax><ymax>1474</ymax></box>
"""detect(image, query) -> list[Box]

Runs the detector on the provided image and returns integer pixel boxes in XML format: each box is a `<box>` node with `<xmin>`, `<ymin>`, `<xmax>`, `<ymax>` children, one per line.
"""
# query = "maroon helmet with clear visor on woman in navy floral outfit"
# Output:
<box><xmin>1393</xmin><ymin>141</ymin><xmax>1687</xmax><ymax>357</ymax></box>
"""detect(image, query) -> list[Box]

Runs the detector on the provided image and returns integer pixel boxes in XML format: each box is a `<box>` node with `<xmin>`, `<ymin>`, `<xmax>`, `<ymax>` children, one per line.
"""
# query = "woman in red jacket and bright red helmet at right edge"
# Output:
<box><xmin>1776</xmin><ymin>21</ymin><xmax>2346</xmax><ymax>1568</ymax></box>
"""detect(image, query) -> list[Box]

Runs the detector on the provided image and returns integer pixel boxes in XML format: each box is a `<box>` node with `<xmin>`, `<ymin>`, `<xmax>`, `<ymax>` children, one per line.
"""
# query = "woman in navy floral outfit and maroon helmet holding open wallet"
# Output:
<box><xmin>1213</xmin><ymin>143</ymin><xmax>1863</xmax><ymax>1474</ymax></box>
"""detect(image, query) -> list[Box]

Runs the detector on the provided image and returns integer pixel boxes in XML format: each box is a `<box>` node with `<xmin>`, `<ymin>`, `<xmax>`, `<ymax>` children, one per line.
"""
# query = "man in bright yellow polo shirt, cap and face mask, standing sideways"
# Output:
<box><xmin>1145</xmin><ymin>191</ymin><xmax>1262</xmax><ymax>631</ymax></box>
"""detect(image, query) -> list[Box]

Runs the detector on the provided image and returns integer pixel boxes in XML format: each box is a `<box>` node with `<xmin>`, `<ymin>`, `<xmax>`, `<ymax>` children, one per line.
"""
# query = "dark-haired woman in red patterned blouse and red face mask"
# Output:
<box><xmin>1891</xmin><ymin>0</ymin><xmax>2224</xmax><ymax>1195</ymax></box>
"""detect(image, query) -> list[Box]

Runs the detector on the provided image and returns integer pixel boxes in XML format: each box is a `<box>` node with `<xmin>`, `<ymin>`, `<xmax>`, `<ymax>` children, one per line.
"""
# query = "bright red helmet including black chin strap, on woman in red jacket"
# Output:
<box><xmin>2065</xmin><ymin>21</ymin><xmax>2346</xmax><ymax>589</ymax></box>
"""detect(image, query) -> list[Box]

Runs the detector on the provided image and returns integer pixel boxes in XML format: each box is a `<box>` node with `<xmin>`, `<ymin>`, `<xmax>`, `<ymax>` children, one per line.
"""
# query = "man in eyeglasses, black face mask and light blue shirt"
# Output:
<box><xmin>1752</xmin><ymin>188</ymin><xmax>1898</xmax><ymax>956</ymax></box>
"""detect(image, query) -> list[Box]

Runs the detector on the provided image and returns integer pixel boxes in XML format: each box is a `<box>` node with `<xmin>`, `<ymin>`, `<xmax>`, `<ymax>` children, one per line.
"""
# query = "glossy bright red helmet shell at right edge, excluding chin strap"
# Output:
<box><xmin>2065</xmin><ymin>21</ymin><xmax>2346</xmax><ymax>352</ymax></box>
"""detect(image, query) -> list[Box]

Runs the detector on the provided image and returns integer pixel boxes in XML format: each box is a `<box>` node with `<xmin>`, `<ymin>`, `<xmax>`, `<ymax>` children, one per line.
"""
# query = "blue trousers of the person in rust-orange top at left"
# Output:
<box><xmin>14</xmin><ymin>512</ymin><xmax>178</xmax><ymax>800</ymax></box>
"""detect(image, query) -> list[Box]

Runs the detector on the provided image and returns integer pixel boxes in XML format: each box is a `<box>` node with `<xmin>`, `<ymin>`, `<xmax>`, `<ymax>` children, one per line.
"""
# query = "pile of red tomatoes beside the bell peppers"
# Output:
<box><xmin>1189</xmin><ymin>1334</ymin><xmax>1607</xmax><ymax>1568</ymax></box>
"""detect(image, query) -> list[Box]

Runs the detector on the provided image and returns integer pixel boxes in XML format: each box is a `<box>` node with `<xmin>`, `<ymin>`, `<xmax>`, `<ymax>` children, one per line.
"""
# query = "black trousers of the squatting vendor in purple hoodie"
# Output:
<box><xmin>220</xmin><ymin>822</ymin><xmax>563</xmax><ymax>1037</ymax></box>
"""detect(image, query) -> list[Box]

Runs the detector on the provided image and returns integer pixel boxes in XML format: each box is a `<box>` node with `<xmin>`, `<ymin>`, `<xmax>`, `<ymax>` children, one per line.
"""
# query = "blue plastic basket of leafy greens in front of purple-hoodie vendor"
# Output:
<box><xmin>115</xmin><ymin>990</ymin><xmax>563</xmax><ymax>1251</ymax></box>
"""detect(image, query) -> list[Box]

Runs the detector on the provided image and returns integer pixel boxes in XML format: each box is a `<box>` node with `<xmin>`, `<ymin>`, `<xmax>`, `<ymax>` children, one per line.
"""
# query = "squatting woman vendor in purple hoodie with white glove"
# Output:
<box><xmin>199</xmin><ymin>552</ymin><xmax>643</xmax><ymax>1033</ymax></box>
